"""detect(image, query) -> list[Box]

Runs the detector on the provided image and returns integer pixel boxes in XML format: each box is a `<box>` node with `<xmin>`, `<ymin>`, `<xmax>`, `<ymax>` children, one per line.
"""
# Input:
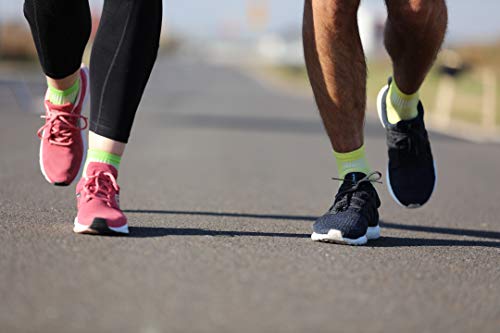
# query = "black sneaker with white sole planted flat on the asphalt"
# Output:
<box><xmin>311</xmin><ymin>172</ymin><xmax>382</xmax><ymax>245</ymax></box>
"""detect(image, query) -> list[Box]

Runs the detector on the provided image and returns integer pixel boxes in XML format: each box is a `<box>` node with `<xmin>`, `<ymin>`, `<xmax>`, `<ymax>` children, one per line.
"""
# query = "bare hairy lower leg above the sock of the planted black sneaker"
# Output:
<box><xmin>303</xmin><ymin>0</ymin><xmax>366</xmax><ymax>153</ymax></box>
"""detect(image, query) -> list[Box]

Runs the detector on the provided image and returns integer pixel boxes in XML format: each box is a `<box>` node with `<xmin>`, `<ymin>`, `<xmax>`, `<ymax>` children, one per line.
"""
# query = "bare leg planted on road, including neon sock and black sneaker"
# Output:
<box><xmin>303</xmin><ymin>0</ymin><xmax>380</xmax><ymax>245</ymax></box>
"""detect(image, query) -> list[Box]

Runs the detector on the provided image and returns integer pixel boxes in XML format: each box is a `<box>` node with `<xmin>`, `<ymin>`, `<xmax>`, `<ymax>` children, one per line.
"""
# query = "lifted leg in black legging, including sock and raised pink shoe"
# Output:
<box><xmin>24</xmin><ymin>0</ymin><xmax>91</xmax><ymax>185</ymax></box>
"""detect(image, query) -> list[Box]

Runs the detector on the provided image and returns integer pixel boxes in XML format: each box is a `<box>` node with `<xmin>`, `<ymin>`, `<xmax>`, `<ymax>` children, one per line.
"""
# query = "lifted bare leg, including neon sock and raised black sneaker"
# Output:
<box><xmin>377</xmin><ymin>0</ymin><xmax>448</xmax><ymax>208</ymax></box>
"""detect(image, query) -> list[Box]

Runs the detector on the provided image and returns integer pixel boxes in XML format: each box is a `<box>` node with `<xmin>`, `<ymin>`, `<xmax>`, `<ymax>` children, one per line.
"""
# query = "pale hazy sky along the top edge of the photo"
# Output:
<box><xmin>0</xmin><ymin>0</ymin><xmax>500</xmax><ymax>42</ymax></box>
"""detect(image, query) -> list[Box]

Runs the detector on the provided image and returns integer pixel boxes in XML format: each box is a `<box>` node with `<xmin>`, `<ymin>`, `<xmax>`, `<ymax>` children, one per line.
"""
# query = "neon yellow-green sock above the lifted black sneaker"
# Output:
<box><xmin>386</xmin><ymin>80</ymin><xmax>420</xmax><ymax>124</ymax></box>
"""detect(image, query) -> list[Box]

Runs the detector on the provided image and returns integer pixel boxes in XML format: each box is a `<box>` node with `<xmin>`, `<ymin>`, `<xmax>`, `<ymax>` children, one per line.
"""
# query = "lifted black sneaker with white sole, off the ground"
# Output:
<box><xmin>377</xmin><ymin>79</ymin><xmax>437</xmax><ymax>208</ymax></box>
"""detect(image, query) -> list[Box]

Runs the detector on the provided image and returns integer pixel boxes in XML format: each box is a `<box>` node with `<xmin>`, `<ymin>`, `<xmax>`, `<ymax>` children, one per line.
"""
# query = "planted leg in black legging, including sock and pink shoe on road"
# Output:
<box><xmin>74</xmin><ymin>0</ymin><xmax>162</xmax><ymax>234</ymax></box>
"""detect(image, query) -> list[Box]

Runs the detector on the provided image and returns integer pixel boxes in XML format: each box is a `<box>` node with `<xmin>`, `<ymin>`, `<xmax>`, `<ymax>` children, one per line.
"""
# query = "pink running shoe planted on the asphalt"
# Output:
<box><xmin>73</xmin><ymin>162</ymin><xmax>128</xmax><ymax>235</ymax></box>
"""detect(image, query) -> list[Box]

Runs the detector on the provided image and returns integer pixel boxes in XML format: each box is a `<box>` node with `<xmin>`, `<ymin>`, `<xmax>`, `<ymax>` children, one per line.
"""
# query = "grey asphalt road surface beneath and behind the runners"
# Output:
<box><xmin>0</xmin><ymin>55</ymin><xmax>500</xmax><ymax>333</ymax></box>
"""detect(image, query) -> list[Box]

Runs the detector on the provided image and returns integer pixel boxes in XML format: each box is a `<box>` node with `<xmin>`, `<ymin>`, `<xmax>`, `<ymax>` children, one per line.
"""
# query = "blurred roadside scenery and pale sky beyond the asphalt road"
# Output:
<box><xmin>0</xmin><ymin>0</ymin><xmax>500</xmax><ymax>140</ymax></box>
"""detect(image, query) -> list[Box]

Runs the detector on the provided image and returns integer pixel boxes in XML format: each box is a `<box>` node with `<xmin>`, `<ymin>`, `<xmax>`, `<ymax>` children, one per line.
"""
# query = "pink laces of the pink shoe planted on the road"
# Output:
<box><xmin>82</xmin><ymin>171</ymin><xmax>120</xmax><ymax>207</ymax></box>
